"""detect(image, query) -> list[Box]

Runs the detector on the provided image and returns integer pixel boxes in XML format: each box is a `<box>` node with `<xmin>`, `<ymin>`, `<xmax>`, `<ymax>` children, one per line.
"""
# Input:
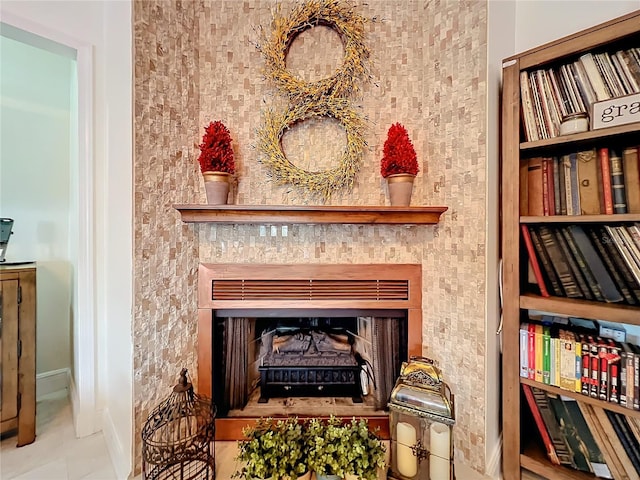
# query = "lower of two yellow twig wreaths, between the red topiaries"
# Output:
<box><xmin>258</xmin><ymin>98</ymin><xmax>365</xmax><ymax>200</ymax></box>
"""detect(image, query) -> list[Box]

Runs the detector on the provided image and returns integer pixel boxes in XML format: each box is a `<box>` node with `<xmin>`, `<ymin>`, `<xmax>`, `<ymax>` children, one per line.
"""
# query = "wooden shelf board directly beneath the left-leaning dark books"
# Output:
<box><xmin>520</xmin><ymin>293</ymin><xmax>640</xmax><ymax>325</ymax></box>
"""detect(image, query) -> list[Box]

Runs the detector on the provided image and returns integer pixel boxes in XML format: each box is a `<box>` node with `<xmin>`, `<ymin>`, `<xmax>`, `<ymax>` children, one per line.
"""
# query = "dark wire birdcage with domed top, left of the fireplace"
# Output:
<box><xmin>142</xmin><ymin>368</ymin><xmax>216</xmax><ymax>480</ymax></box>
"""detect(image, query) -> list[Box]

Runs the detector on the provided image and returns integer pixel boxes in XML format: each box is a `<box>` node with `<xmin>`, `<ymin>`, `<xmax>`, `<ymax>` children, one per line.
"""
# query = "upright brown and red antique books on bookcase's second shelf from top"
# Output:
<box><xmin>520</xmin><ymin>146</ymin><xmax>640</xmax><ymax>216</ymax></box>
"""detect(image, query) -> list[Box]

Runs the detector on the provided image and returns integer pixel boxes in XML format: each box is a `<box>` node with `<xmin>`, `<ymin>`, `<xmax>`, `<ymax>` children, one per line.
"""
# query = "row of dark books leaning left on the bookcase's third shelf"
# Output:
<box><xmin>521</xmin><ymin>223</ymin><xmax>640</xmax><ymax>305</ymax></box>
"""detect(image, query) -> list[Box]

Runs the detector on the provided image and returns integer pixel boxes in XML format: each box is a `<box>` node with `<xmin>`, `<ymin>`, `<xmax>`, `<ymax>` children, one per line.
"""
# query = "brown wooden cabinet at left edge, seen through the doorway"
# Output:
<box><xmin>0</xmin><ymin>264</ymin><xmax>36</xmax><ymax>447</ymax></box>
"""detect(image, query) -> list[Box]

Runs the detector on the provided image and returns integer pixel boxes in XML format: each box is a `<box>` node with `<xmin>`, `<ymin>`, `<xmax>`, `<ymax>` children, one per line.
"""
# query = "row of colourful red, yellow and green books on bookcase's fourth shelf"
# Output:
<box><xmin>520</xmin><ymin>315</ymin><xmax>640</xmax><ymax>410</ymax></box>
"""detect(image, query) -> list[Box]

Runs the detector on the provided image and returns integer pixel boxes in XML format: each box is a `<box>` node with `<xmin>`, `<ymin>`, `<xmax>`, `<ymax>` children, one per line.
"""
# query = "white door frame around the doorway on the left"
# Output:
<box><xmin>2</xmin><ymin>12</ymin><xmax>100</xmax><ymax>437</ymax></box>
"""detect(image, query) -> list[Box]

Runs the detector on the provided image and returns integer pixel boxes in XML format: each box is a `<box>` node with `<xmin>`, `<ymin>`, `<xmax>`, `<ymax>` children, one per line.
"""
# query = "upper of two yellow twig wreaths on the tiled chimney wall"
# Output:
<box><xmin>257</xmin><ymin>0</ymin><xmax>370</xmax><ymax>98</ymax></box>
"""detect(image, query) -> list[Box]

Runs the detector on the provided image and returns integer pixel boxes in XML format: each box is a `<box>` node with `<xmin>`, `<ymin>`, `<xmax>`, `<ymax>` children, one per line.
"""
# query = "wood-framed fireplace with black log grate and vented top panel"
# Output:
<box><xmin>198</xmin><ymin>264</ymin><xmax>422</xmax><ymax>440</ymax></box>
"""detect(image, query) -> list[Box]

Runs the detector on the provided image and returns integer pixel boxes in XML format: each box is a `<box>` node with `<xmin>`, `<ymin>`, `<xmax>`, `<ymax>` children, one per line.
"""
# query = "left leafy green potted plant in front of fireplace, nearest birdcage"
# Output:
<box><xmin>232</xmin><ymin>417</ymin><xmax>308</xmax><ymax>480</ymax></box>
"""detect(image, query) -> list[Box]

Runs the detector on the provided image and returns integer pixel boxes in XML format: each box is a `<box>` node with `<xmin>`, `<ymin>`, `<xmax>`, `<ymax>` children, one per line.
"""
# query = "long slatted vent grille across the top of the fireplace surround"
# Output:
<box><xmin>212</xmin><ymin>280</ymin><xmax>409</xmax><ymax>301</ymax></box>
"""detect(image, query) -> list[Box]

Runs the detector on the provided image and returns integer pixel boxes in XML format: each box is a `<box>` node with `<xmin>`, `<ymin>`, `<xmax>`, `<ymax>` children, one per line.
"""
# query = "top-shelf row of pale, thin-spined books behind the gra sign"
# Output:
<box><xmin>520</xmin><ymin>47</ymin><xmax>640</xmax><ymax>141</ymax></box>
